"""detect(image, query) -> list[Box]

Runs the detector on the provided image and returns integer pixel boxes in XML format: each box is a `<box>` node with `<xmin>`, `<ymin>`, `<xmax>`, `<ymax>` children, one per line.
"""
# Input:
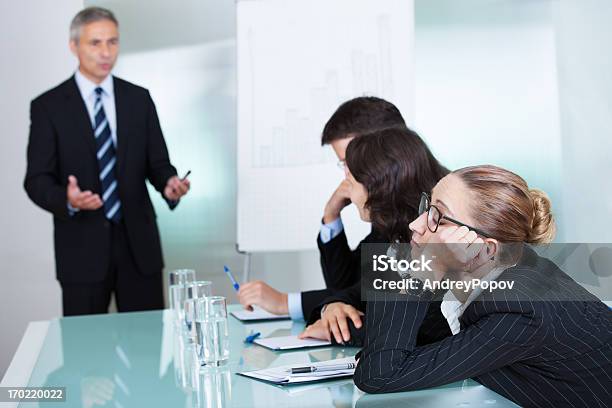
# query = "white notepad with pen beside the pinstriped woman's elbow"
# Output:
<box><xmin>238</xmin><ymin>357</ymin><xmax>355</xmax><ymax>385</ymax></box>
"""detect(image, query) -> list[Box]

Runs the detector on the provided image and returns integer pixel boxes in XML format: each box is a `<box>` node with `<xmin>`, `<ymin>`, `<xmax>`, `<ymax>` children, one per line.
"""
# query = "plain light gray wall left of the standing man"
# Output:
<box><xmin>0</xmin><ymin>0</ymin><xmax>83</xmax><ymax>375</ymax></box>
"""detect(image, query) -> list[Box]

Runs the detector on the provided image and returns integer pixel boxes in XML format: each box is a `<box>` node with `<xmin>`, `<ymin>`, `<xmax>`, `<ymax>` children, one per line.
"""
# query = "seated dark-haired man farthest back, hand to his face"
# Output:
<box><xmin>238</xmin><ymin>97</ymin><xmax>406</xmax><ymax>324</ymax></box>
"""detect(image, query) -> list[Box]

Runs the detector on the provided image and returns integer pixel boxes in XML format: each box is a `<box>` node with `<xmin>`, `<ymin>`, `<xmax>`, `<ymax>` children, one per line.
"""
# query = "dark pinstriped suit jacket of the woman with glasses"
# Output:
<box><xmin>354</xmin><ymin>248</ymin><xmax>612</xmax><ymax>407</ymax></box>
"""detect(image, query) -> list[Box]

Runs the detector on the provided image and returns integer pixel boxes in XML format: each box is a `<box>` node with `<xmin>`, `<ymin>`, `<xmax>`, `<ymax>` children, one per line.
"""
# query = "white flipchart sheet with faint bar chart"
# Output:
<box><xmin>237</xmin><ymin>0</ymin><xmax>414</xmax><ymax>251</ymax></box>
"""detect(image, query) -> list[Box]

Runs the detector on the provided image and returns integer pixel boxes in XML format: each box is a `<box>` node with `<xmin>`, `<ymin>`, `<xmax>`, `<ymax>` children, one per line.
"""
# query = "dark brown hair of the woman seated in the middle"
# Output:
<box><xmin>346</xmin><ymin>128</ymin><xmax>449</xmax><ymax>242</ymax></box>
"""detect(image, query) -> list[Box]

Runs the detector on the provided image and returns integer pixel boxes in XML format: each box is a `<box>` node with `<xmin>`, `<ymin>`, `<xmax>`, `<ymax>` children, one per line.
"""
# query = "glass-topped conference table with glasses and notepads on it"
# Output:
<box><xmin>3</xmin><ymin>305</ymin><xmax>516</xmax><ymax>408</ymax></box>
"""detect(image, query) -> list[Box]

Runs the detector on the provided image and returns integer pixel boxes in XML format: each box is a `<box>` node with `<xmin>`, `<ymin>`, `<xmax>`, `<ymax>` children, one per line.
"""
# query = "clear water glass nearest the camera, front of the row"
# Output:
<box><xmin>194</xmin><ymin>296</ymin><xmax>229</xmax><ymax>366</ymax></box>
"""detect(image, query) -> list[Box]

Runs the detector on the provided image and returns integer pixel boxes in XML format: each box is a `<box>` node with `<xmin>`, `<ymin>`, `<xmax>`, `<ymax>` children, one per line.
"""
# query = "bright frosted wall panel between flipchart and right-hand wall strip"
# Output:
<box><xmin>415</xmin><ymin>0</ymin><xmax>564</xmax><ymax>240</ymax></box>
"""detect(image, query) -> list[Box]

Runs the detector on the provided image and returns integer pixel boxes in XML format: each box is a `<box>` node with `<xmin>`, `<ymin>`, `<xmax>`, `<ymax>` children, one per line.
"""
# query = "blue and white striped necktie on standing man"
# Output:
<box><xmin>94</xmin><ymin>87</ymin><xmax>121</xmax><ymax>223</ymax></box>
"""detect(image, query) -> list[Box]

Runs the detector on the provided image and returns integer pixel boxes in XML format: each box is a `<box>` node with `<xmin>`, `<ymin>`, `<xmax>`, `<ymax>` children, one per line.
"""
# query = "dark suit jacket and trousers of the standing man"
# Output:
<box><xmin>24</xmin><ymin>77</ymin><xmax>176</xmax><ymax>314</ymax></box>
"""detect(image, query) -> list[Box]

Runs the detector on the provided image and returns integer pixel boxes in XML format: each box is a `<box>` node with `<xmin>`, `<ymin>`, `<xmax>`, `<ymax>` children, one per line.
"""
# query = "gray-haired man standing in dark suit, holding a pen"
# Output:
<box><xmin>24</xmin><ymin>7</ymin><xmax>189</xmax><ymax>316</ymax></box>
